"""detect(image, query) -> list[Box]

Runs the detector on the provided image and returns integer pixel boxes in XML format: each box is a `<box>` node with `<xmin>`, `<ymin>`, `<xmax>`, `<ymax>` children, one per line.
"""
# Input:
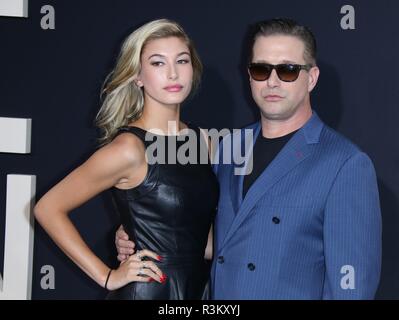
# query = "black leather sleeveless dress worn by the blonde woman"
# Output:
<box><xmin>107</xmin><ymin>125</ymin><xmax>219</xmax><ymax>300</ymax></box>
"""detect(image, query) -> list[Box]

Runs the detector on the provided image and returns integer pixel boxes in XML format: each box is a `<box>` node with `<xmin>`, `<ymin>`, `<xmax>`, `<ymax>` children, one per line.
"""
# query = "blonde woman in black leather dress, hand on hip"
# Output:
<box><xmin>34</xmin><ymin>19</ymin><xmax>219</xmax><ymax>299</ymax></box>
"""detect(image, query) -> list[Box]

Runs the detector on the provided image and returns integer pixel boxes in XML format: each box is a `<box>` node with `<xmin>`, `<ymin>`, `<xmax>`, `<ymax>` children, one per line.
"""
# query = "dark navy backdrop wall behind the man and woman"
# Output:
<box><xmin>0</xmin><ymin>0</ymin><xmax>399</xmax><ymax>299</ymax></box>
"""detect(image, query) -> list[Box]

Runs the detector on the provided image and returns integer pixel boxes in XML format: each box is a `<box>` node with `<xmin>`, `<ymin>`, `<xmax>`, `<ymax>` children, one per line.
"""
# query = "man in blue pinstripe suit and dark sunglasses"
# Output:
<box><xmin>117</xmin><ymin>19</ymin><xmax>381</xmax><ymax>299</ymax></box>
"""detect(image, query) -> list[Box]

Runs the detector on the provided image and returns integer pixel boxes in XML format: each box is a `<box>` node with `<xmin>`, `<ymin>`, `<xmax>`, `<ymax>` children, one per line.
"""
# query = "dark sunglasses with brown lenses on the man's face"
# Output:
<box><xmin>248</xmin><ymin>63</ymin><xmax>312</xmax><ymax>82</ymax></box>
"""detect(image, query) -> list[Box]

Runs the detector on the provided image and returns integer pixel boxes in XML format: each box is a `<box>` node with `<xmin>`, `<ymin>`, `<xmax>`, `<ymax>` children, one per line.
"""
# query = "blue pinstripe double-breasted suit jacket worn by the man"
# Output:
<box><xmin>211</xmin><ymin>113</ymin><xmax>381</xmax><ymax>299</ymax></box>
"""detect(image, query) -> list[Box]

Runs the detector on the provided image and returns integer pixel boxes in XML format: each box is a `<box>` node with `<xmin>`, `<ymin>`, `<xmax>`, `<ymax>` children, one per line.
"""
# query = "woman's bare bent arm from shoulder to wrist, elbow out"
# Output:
<box><xmin>34</xmin><ymin>133</ymin><xmax>162</xmax><ymax>286</ymax></box>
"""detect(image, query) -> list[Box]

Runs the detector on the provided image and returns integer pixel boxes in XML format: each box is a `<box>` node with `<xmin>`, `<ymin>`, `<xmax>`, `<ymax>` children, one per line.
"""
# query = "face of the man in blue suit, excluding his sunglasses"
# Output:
<box><xmin>250</xmin><ymin>35</ymin><xmax>319</xmax><ymax>121</ymax></box>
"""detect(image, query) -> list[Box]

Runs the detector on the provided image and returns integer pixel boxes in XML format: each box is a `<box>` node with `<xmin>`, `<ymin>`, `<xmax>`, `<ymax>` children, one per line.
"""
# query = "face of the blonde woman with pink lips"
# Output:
<box><xmin>137</xmin><ymin>37</ymin><xmax>193</xmax><ymax>105</ymax></box>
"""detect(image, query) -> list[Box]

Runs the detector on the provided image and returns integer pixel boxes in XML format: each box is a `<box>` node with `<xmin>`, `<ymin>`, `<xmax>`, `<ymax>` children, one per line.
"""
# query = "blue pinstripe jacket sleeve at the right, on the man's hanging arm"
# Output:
<box><xmin>323</xmin><ymin>152</ymin><xmax>382</xmax><ymax>299</ymax></box>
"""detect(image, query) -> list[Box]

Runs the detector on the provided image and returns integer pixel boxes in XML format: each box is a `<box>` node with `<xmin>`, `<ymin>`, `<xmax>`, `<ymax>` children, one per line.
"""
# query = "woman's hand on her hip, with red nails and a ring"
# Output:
<box><xmin>106</xmin><ymin>250</ymin><xmax>167</xmax><ymax>290</ymax></box>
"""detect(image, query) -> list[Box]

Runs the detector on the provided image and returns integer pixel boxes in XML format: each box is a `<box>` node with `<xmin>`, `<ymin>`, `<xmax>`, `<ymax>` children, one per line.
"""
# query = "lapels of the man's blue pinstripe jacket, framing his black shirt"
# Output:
<box><xmin>222</xmin><ymin>112</ymin><xmax>323</xmax><ymax>250</ymax></box>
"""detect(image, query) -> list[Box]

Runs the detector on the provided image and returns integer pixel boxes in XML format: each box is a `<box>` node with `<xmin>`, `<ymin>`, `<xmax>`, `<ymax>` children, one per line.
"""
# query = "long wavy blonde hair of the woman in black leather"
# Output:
<box><xmin>96</xmin><ymin>19</ymin><xmax>202</xmax><ymax>145</ymax></box>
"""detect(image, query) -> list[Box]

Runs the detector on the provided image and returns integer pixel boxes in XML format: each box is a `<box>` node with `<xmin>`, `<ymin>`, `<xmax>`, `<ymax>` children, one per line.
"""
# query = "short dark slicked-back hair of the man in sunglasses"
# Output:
<box><xmin>248</xmin><ymin>18</ymin><xmax>316</xmax><ymax>66</ymax></box>
